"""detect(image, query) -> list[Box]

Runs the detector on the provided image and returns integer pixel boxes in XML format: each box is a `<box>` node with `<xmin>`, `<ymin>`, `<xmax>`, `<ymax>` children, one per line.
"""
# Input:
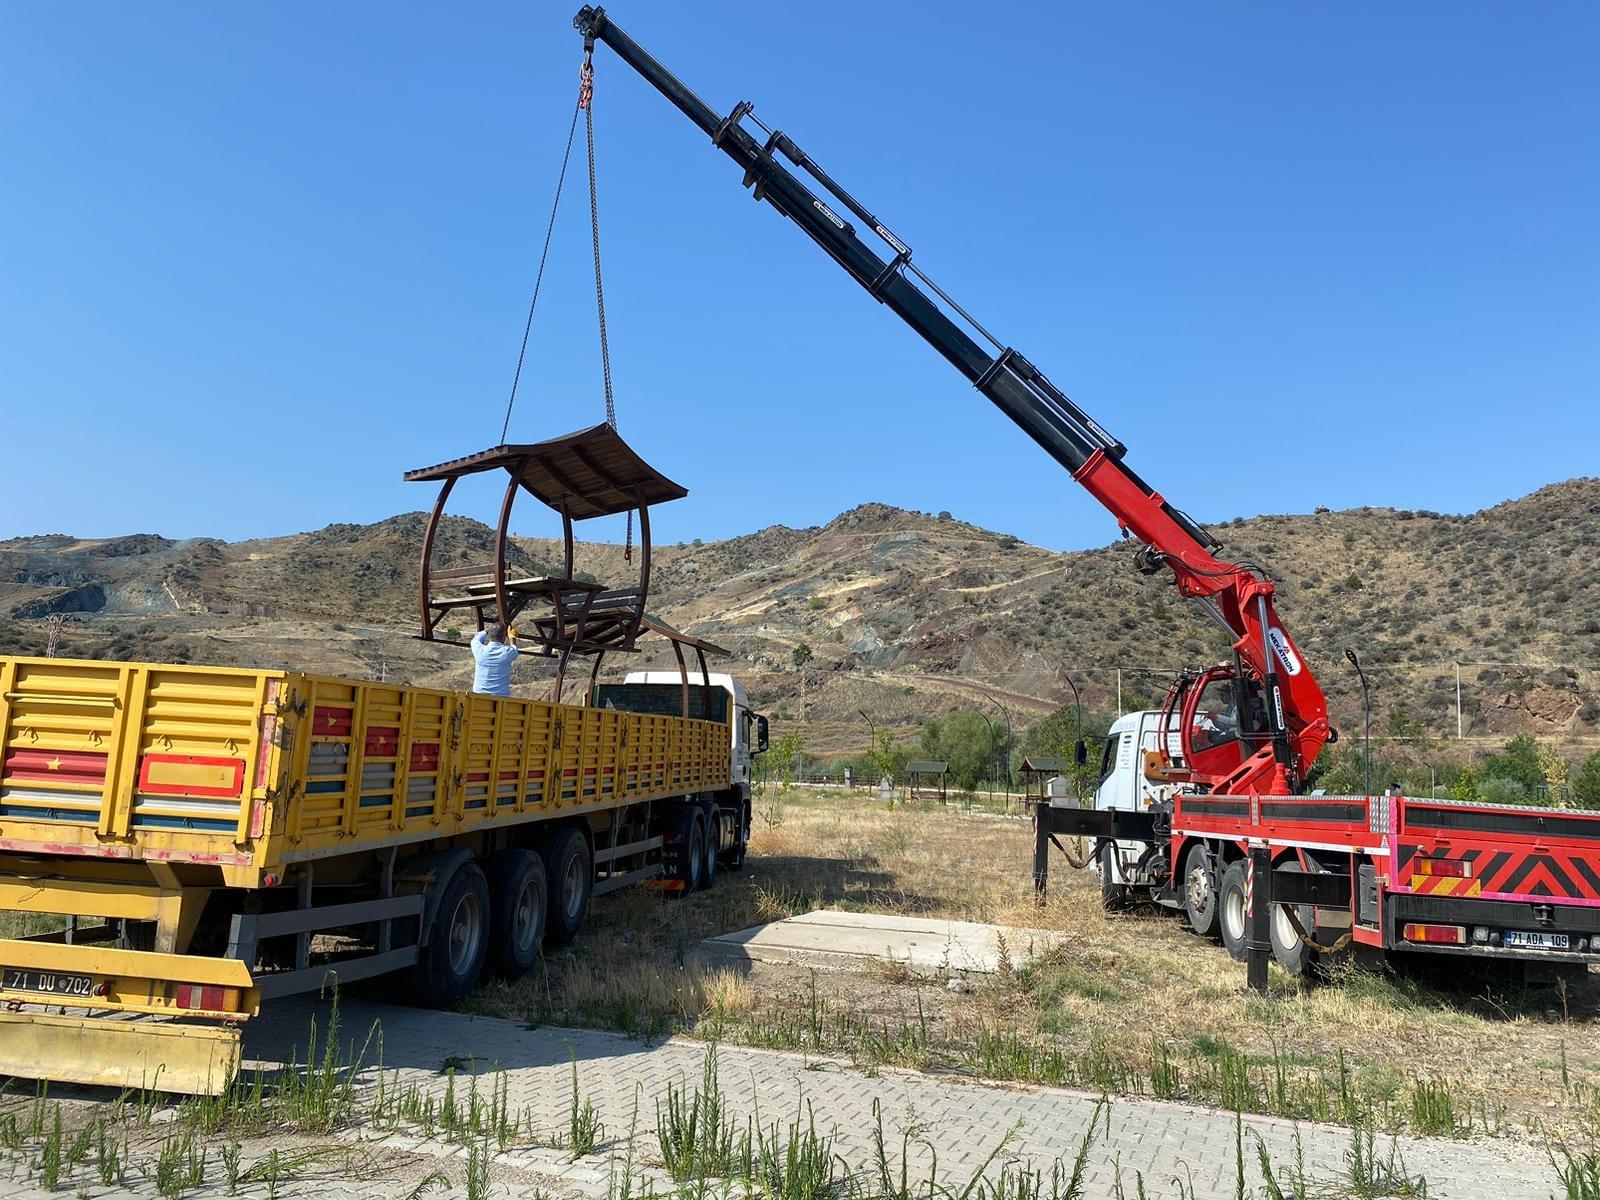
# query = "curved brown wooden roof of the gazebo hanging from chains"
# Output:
<box><xmin>405</xmin><ymin>424</ymin><xmax>690</xmax><ymax>520</ymax></box>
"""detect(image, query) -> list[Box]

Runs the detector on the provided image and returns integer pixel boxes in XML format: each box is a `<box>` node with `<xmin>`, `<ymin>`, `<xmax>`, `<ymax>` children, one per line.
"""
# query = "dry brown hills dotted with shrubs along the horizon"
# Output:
<box><xmin>0</xmin><ymin>478</ymin><xmax>1600</xmax><ymax>754</ymax></box>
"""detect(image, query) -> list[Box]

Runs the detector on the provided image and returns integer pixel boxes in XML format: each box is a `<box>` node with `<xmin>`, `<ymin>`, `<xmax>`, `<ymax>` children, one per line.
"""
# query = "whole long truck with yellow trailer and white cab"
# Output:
<box><xmin>0</xmin><ymin>658</ymin><xmax>766</xmax><ymax>1093</ymax></box>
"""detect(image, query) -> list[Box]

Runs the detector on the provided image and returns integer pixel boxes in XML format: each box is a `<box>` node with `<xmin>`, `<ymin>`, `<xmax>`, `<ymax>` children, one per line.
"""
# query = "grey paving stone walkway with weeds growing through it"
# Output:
<box><xmin>0</xmin><ymin>1000</ymin><xmax>1558</xmax><ymax>1200</ymax></box>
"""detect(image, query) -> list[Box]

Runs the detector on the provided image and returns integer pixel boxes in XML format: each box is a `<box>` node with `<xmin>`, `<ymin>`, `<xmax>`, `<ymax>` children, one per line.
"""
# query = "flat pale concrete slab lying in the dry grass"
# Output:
<box><xmin>696</xmin><ymin>909</ymin><xmax>1062</xmax><ymax>976</ymax></box>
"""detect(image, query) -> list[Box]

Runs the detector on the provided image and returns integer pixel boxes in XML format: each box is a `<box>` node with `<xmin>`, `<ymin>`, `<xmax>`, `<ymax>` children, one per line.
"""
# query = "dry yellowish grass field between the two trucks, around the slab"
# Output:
<box><xmin>475</xmin><ymin>792</ymin><xmax>1600</xmax><ymax>1131</ymax></box>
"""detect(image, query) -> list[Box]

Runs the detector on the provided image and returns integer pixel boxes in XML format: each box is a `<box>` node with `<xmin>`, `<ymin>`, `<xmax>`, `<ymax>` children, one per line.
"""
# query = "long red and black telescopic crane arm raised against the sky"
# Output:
<box><xmin>573</xmin><ymin>5</ymin><xmax>1330</xmax><ymax>794</ymax></box>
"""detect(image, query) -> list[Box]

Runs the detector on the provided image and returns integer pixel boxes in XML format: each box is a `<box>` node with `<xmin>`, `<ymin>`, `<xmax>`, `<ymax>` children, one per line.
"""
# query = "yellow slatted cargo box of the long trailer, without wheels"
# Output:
<box><xmin>0</xmin><ymin>658</ymin><xmax>730</xmax><ymax>888</ymax></box>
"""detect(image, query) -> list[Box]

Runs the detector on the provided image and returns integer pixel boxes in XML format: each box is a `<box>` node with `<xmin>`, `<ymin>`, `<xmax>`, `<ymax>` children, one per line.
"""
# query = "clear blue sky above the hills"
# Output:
<box><xmin>0</xmin><ymin>0</ymin><xmax>1600</xmax><ymax>547</ymax></box>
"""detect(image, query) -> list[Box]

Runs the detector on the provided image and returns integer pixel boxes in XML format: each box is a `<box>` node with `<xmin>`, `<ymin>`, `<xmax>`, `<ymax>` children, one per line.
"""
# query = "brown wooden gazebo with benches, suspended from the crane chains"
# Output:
<box><xmin>405</xmin><ymin>424</ymin><xmax>688</xmax><ymax>672</ymax></box>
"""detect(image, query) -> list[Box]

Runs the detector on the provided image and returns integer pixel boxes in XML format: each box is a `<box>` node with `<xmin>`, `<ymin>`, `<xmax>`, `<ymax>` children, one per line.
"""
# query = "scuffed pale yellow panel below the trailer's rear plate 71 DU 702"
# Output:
<box><xmin>0</xmin><ymin>1011</ymin><xmax>238</xmax><ymax>1096</ymax></box>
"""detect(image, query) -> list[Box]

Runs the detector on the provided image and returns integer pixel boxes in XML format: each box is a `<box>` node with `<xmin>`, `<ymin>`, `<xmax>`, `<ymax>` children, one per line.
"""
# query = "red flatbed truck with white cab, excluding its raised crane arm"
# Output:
<box><xmin>1035</xmin><ymin>709</ymin><xmax>1600</xmax><ymax>976</ymax></box>
